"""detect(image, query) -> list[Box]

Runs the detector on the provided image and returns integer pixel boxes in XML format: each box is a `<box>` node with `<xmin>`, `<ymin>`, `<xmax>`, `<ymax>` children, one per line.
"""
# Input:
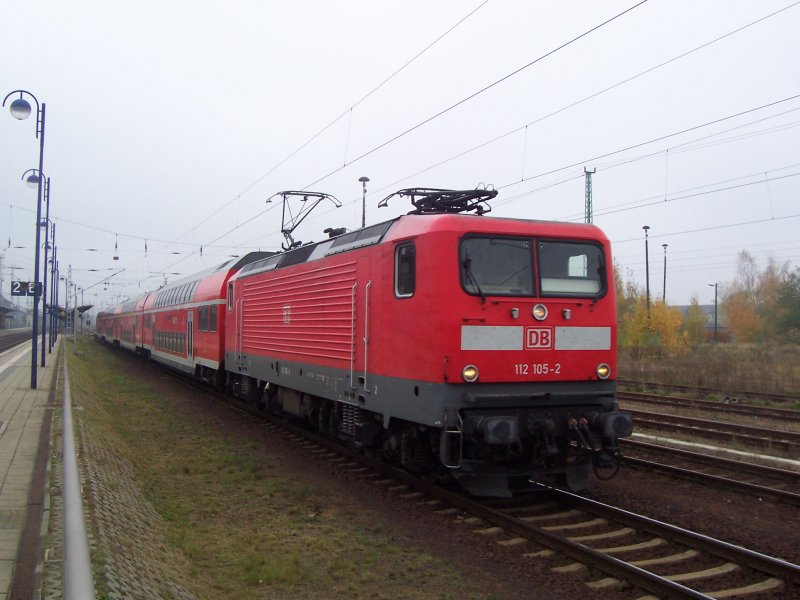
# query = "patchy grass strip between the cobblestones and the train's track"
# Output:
<box><xmin>69</xmin><ymin>340</ymin><xmax>500</xmax><ymax>598</ymax></box>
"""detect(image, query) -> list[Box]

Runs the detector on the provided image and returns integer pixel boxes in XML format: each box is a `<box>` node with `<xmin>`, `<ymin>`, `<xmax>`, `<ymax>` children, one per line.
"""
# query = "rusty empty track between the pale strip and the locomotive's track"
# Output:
<box><xmin>621</xmin><ymin>440</ymin><xmax>800</xmax><ymax>506</ymax></box>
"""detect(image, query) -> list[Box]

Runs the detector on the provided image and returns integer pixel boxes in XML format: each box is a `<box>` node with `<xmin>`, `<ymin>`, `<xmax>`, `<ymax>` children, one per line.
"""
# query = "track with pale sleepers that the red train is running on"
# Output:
<box><xmin>150</xmin><ymin>354</ymin><xmax>800</xmax><ymax>598</ymax></box>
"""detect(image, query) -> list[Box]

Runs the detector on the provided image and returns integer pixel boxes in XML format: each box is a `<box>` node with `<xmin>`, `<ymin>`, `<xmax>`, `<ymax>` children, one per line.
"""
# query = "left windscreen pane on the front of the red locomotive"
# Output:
<box><xmin>459</xmin><ymin>237</ymin><xmax>533</xmax><ymax>296</ymax></box>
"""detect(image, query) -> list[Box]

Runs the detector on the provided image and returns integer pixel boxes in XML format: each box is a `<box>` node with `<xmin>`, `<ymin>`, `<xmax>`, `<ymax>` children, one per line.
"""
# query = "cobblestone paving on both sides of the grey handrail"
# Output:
<box><xmin>41</xmin><ymin>413</ymin><xmax>194</xmax><ymax>600</ymax></box>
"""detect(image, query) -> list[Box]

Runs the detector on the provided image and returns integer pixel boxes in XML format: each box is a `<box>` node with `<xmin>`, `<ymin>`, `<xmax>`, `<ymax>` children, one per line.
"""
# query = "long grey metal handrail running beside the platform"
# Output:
<box><xmin>62</xmin><ymin>352</ymin><xmax>95</xmax><ymax>600</ymax></box>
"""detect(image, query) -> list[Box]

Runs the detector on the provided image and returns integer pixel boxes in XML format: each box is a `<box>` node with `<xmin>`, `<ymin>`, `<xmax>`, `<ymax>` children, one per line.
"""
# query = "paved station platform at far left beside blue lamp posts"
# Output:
<box><xmin>0</xmin><ymin>336</ymin><xmax>63</xmax><ymax>600</ymax></box>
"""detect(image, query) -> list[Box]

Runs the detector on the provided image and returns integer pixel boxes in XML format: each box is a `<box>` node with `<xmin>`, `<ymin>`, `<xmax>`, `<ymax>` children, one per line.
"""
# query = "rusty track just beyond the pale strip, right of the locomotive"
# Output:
<box><xmin>626</xmin><ymin>409</ymin><xmax>800</xmax><ymax>453</ymax></box>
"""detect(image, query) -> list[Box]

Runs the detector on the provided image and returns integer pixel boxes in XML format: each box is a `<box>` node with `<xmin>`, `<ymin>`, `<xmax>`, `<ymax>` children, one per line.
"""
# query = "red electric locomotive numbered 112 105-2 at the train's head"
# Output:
<box><xmin>225</xmin><ymin>190</ymin><xmax>632</xmax><ymax>495</ymax></box>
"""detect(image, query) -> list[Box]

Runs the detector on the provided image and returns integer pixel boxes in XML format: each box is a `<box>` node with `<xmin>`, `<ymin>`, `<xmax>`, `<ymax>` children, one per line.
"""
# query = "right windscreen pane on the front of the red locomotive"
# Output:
<box><xmin>537</xmin><ymin>241</ymin><xmax>606</xmax><ymax>296</ymax></box>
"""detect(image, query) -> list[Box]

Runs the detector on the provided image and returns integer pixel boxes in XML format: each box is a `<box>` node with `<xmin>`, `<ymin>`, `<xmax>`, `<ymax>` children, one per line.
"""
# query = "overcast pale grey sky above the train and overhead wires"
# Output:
<box><xmin>0</xmin><ymin>0</ymin><xmax>800</xmax><ymax>314</ymax></box>
